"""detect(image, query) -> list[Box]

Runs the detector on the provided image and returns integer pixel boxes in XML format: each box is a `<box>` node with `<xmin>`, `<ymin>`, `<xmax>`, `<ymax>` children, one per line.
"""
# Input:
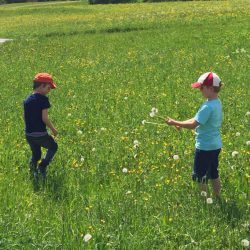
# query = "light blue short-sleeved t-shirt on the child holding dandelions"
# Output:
<box><xmin>194</xmin><ymin>99</ymin><xmax>222</xmax><ymax>150</ymax></box>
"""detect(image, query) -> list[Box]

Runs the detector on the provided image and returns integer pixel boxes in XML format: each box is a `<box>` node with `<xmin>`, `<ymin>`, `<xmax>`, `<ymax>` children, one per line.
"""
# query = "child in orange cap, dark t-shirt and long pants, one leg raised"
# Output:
<box><xmin>24</xmin><ymin>73</ymin><xmax>58</xmax><ymax>178</ymax></box>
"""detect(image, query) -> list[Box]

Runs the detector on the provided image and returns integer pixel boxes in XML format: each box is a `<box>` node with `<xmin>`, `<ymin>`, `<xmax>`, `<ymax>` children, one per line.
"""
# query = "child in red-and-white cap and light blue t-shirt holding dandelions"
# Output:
<box><xmin>166</xmin><ymin>72</ymin><xmax>222</xmax><ymax>197</ymax></box>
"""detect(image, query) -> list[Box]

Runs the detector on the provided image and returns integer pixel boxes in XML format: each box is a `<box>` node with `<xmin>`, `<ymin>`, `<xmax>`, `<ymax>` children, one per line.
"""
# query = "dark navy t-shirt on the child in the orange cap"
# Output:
<box><xmin>23</xmin><ymin>93</ymin><xmax>50</xmax><ymax>134</ymax></box>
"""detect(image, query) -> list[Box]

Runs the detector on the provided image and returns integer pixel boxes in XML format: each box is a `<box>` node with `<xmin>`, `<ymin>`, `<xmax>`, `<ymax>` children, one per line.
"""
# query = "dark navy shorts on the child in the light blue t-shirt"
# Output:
<box><xmin>192</xmin><ymin>149</ymin><xmax>221</xmax><ymax>183</ymax></box>
